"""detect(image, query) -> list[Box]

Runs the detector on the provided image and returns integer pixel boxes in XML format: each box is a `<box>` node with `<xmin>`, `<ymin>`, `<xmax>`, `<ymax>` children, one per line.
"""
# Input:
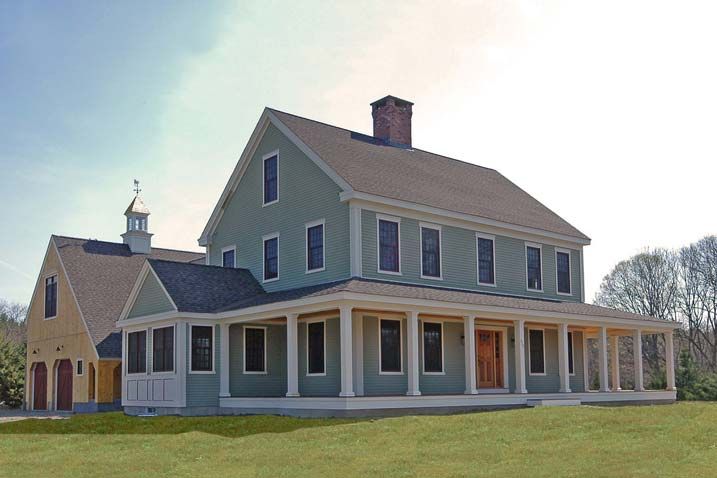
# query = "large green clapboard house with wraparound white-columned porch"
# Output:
<box><xmin>117</xmin><ymin>96</ymin><xmax>676</xmax><ymax>415</ymax></box>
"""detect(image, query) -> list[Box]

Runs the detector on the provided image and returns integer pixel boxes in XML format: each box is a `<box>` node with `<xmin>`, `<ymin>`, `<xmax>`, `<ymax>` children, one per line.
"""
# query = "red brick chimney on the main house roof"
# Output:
<box><xmin>371</xmin><ymin>95</ymin><xmax>413</xmax><ymax>146</ymax></box>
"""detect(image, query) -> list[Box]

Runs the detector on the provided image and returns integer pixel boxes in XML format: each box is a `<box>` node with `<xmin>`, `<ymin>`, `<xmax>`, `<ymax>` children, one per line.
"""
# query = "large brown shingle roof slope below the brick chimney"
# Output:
<box><xmin>270</xmin><ymin>109</ymin><xmax>589</xmax><ymax>240</ymax></box>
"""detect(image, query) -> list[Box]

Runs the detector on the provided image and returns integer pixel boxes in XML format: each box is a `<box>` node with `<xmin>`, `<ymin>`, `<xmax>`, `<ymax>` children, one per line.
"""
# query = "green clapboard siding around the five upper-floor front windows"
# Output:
<box><xmin>361</xmin><ymin>209</ymin><xmax>582</xmax><ymax>301</ymax></box>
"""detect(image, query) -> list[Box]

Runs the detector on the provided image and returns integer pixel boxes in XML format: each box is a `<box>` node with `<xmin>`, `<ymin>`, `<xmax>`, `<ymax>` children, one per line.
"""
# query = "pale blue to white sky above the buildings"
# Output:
<box><xmin>0</xmin><ymin>0</ymin><xmax>717</xmax><ymax>302</ymax></box>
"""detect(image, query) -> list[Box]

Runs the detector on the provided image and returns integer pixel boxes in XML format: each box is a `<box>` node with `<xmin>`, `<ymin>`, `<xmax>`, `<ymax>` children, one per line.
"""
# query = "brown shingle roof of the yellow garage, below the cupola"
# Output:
<box><xmin>52</xmin><ymin>235</ymin><xmax>204</xmax><ymax>358</ymax></box>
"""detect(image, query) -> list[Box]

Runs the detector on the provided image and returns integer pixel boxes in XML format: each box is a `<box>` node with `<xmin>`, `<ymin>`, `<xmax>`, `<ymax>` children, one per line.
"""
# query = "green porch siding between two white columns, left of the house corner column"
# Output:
<box><xmin>298</xmin><ymin>318</ymin><xmax>341</xmax><ymax>397</ymax></box>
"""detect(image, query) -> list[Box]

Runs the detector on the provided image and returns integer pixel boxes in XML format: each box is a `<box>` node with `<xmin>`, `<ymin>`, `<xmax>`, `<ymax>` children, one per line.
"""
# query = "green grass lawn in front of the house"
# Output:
<box><xmin>0</xmin><ymin>403</ymin><xmax>717</xmax><ymax>478</ymax></box>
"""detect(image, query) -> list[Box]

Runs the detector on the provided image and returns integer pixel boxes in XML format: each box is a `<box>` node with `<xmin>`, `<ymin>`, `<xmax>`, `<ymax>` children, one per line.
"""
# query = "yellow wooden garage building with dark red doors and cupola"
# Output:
<box><xmin>25</xmin><ymin>196</ymin><xmax>204</xmax><ymax>412</ymax></box>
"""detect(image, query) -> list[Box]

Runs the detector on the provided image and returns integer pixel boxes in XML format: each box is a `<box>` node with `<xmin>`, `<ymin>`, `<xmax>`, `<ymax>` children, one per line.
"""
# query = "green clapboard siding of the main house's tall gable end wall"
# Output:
<box><xmin>210</xmin><ymin>125</ymin><xmax>350</xmax><ymax>291</ymax></box>
